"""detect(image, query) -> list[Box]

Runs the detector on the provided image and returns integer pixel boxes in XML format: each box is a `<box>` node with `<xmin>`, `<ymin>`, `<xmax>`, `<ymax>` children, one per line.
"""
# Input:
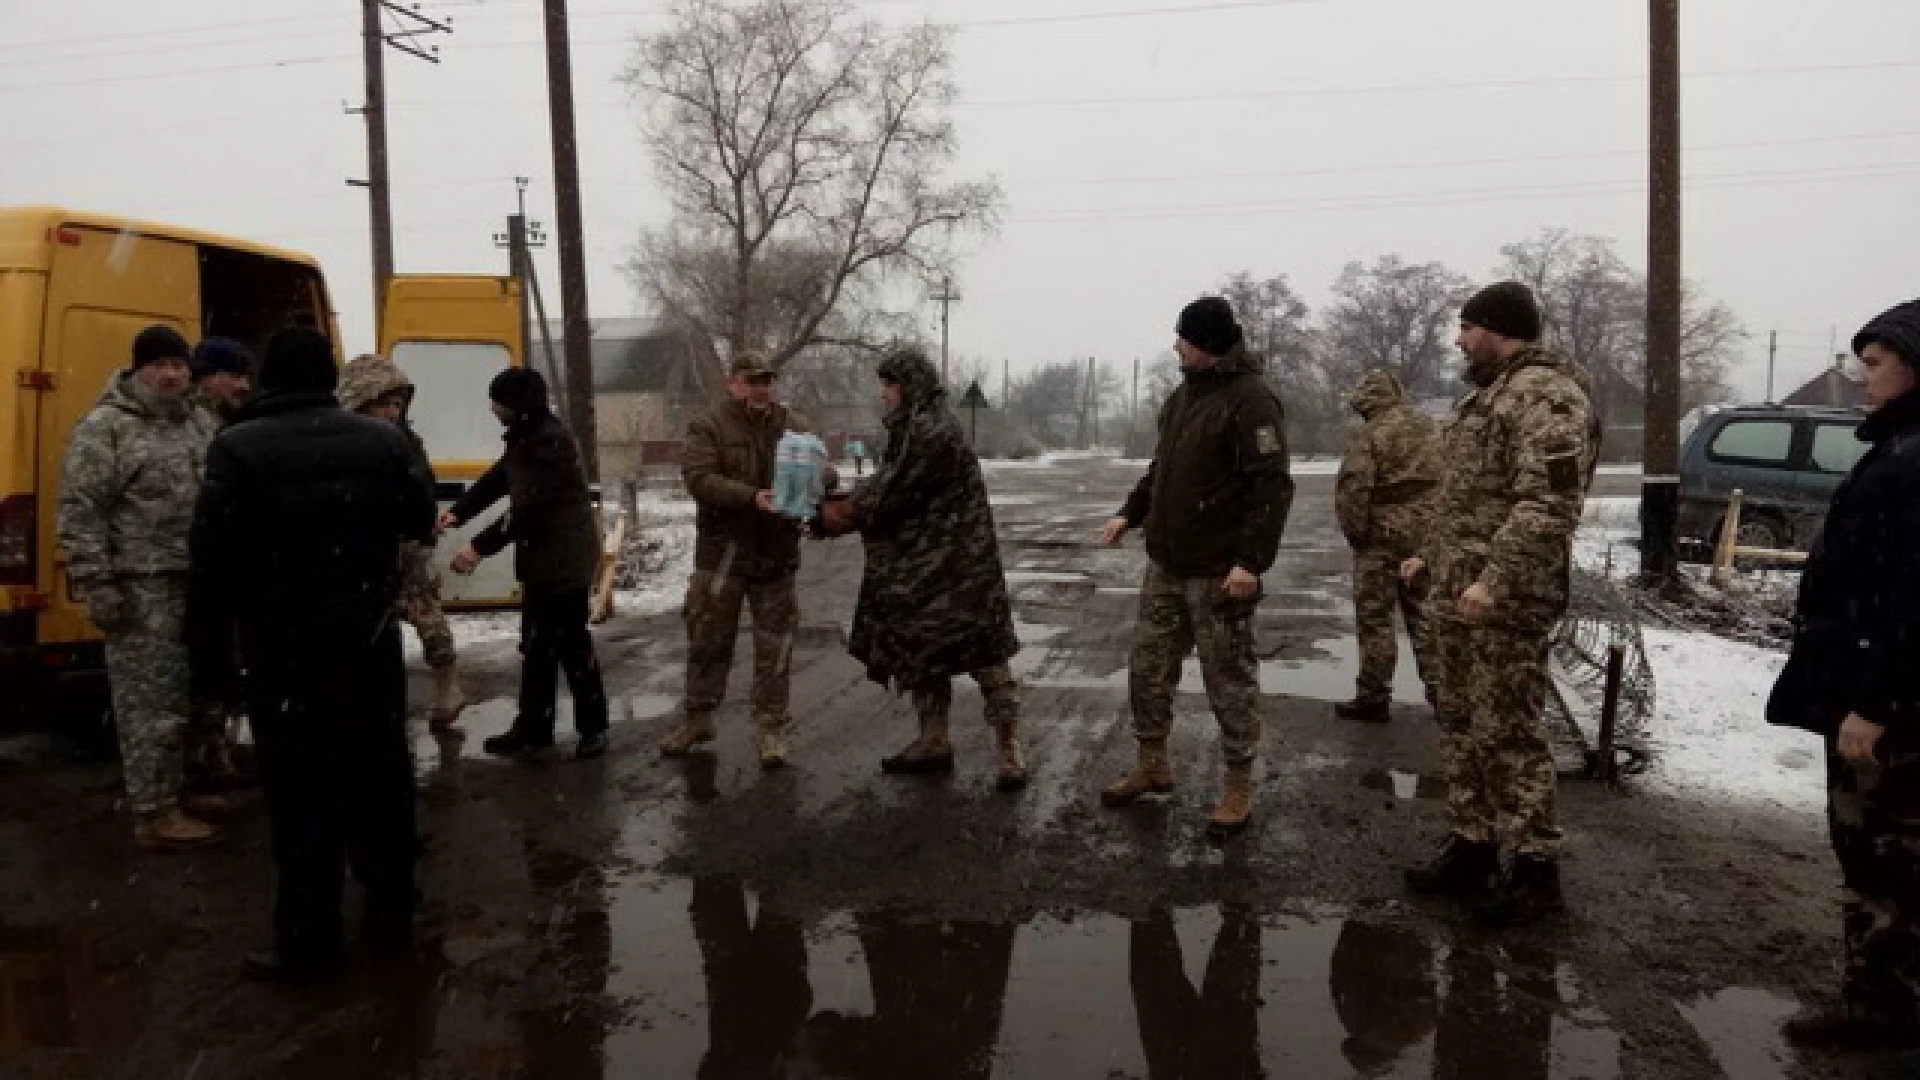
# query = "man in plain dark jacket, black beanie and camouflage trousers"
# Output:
<box><xmin>1102</xmin><ymin>296</ymin><xmax>1294</xmax><ymax>838</ymax></box>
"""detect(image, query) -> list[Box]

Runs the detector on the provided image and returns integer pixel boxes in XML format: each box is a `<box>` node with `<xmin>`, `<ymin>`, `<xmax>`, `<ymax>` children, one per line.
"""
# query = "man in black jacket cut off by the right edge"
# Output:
<box><xmin>1766</xmin><ymin>300</ymin><xmax>1920</xmax><ymax>1047</ymax></box>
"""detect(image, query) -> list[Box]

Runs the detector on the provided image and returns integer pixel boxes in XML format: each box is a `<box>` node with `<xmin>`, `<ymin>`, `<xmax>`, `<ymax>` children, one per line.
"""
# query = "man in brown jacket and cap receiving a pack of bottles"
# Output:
<box><xmin>660</xmin><ymin>352</ymin><xmax>812</xmax><ymax>769</ymax></box>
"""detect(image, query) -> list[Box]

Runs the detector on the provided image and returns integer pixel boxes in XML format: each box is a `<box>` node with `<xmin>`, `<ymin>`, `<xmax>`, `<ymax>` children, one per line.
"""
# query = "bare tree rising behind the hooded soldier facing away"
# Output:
<box><xmin>1321</xmin><ymin>256</ymin><xmax>1469</xmax><ymax>394</ymax></box>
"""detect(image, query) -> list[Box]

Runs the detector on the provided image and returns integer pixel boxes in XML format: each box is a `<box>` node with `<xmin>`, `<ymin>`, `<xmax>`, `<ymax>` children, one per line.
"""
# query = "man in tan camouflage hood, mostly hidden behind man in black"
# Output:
<box><xmin>338</xmin><ymin>354</ymin><xmax>467</xmax><ymax>732</ymax></box>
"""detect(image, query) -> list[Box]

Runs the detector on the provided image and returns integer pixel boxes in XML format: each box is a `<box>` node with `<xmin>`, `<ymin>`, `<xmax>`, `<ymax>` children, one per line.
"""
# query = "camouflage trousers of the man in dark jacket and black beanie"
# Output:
<box><xmin>1127</xmin><ymin>561</ymin><xmax>1260</xmax><ymax>765</ymax></box>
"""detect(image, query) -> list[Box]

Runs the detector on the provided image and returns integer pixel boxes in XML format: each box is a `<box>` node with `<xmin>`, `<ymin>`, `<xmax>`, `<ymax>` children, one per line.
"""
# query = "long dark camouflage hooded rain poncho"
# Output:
<box><xmin>847</xmin><ymin>354</ymin><xmax>1020</xmax><ymax>690</ymax></box>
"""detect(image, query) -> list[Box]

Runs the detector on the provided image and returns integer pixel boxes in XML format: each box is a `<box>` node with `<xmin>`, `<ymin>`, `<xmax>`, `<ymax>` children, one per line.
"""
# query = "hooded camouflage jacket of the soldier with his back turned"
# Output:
<box><xmin>1332</xmin><ymin>371</ymin><xmax>1440</xmax><ymax>553</ymax></box>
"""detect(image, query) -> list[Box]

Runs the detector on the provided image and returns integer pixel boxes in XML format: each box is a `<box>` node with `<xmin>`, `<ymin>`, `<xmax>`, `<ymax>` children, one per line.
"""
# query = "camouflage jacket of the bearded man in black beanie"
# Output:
<box><xmin>1423</xmin><ymin>346</ymin><xmax>1599</xmax><ymax>621</ymax></box>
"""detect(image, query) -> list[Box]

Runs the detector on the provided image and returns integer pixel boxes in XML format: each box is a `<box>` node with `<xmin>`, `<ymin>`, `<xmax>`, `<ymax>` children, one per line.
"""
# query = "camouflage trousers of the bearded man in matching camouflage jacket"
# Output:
<box><xmin>1430</xmin><ymin>611</ymin><xmax>1561</xmax><ymax>855</ymax></box>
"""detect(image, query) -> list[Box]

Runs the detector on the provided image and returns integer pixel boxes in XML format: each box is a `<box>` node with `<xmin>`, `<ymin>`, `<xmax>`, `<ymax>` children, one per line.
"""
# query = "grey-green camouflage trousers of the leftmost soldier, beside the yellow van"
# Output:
<box><xmin>108</xmin><ymin>577</ymin><xmax>188</xmax><ymax>817</ymax></box>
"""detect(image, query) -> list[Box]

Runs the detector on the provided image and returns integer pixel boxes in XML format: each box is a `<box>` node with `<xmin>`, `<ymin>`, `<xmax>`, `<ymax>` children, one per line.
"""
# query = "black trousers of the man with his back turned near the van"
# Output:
<box><xmin>250</xmin><ymin>625</ymin><xmax>419</xmax><ymax>963</ymax></box>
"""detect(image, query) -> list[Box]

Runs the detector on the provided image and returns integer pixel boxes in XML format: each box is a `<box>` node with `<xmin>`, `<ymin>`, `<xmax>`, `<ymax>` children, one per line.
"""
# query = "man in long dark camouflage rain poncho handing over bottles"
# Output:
<box><xmin>822</xmin><ymin>350</ymin><xmax>1027</xmax><ymax>792</ymax></box>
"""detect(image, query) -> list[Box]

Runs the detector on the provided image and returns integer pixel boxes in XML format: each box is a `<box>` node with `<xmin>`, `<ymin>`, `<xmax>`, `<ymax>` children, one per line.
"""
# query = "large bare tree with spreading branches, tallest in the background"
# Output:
<box><xmin>622</xmin><ymin>0</ymin><xmax>1002</xmax><ymax>367</ymax></box>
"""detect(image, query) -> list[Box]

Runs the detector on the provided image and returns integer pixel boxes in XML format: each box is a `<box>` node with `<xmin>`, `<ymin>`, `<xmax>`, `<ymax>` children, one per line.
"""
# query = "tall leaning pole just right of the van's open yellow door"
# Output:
<box><xmin>545</xmin><ymin>0</ymin><xmax>599</xmax><ymax>480</ymax></box>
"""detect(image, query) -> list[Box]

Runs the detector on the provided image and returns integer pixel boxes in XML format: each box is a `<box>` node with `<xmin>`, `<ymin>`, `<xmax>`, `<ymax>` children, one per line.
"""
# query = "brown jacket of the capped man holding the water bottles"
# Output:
<box><xmin>680</xmin><ymin>400</ymin><xmax>812</xmax><ymax>578</ymax></box>
